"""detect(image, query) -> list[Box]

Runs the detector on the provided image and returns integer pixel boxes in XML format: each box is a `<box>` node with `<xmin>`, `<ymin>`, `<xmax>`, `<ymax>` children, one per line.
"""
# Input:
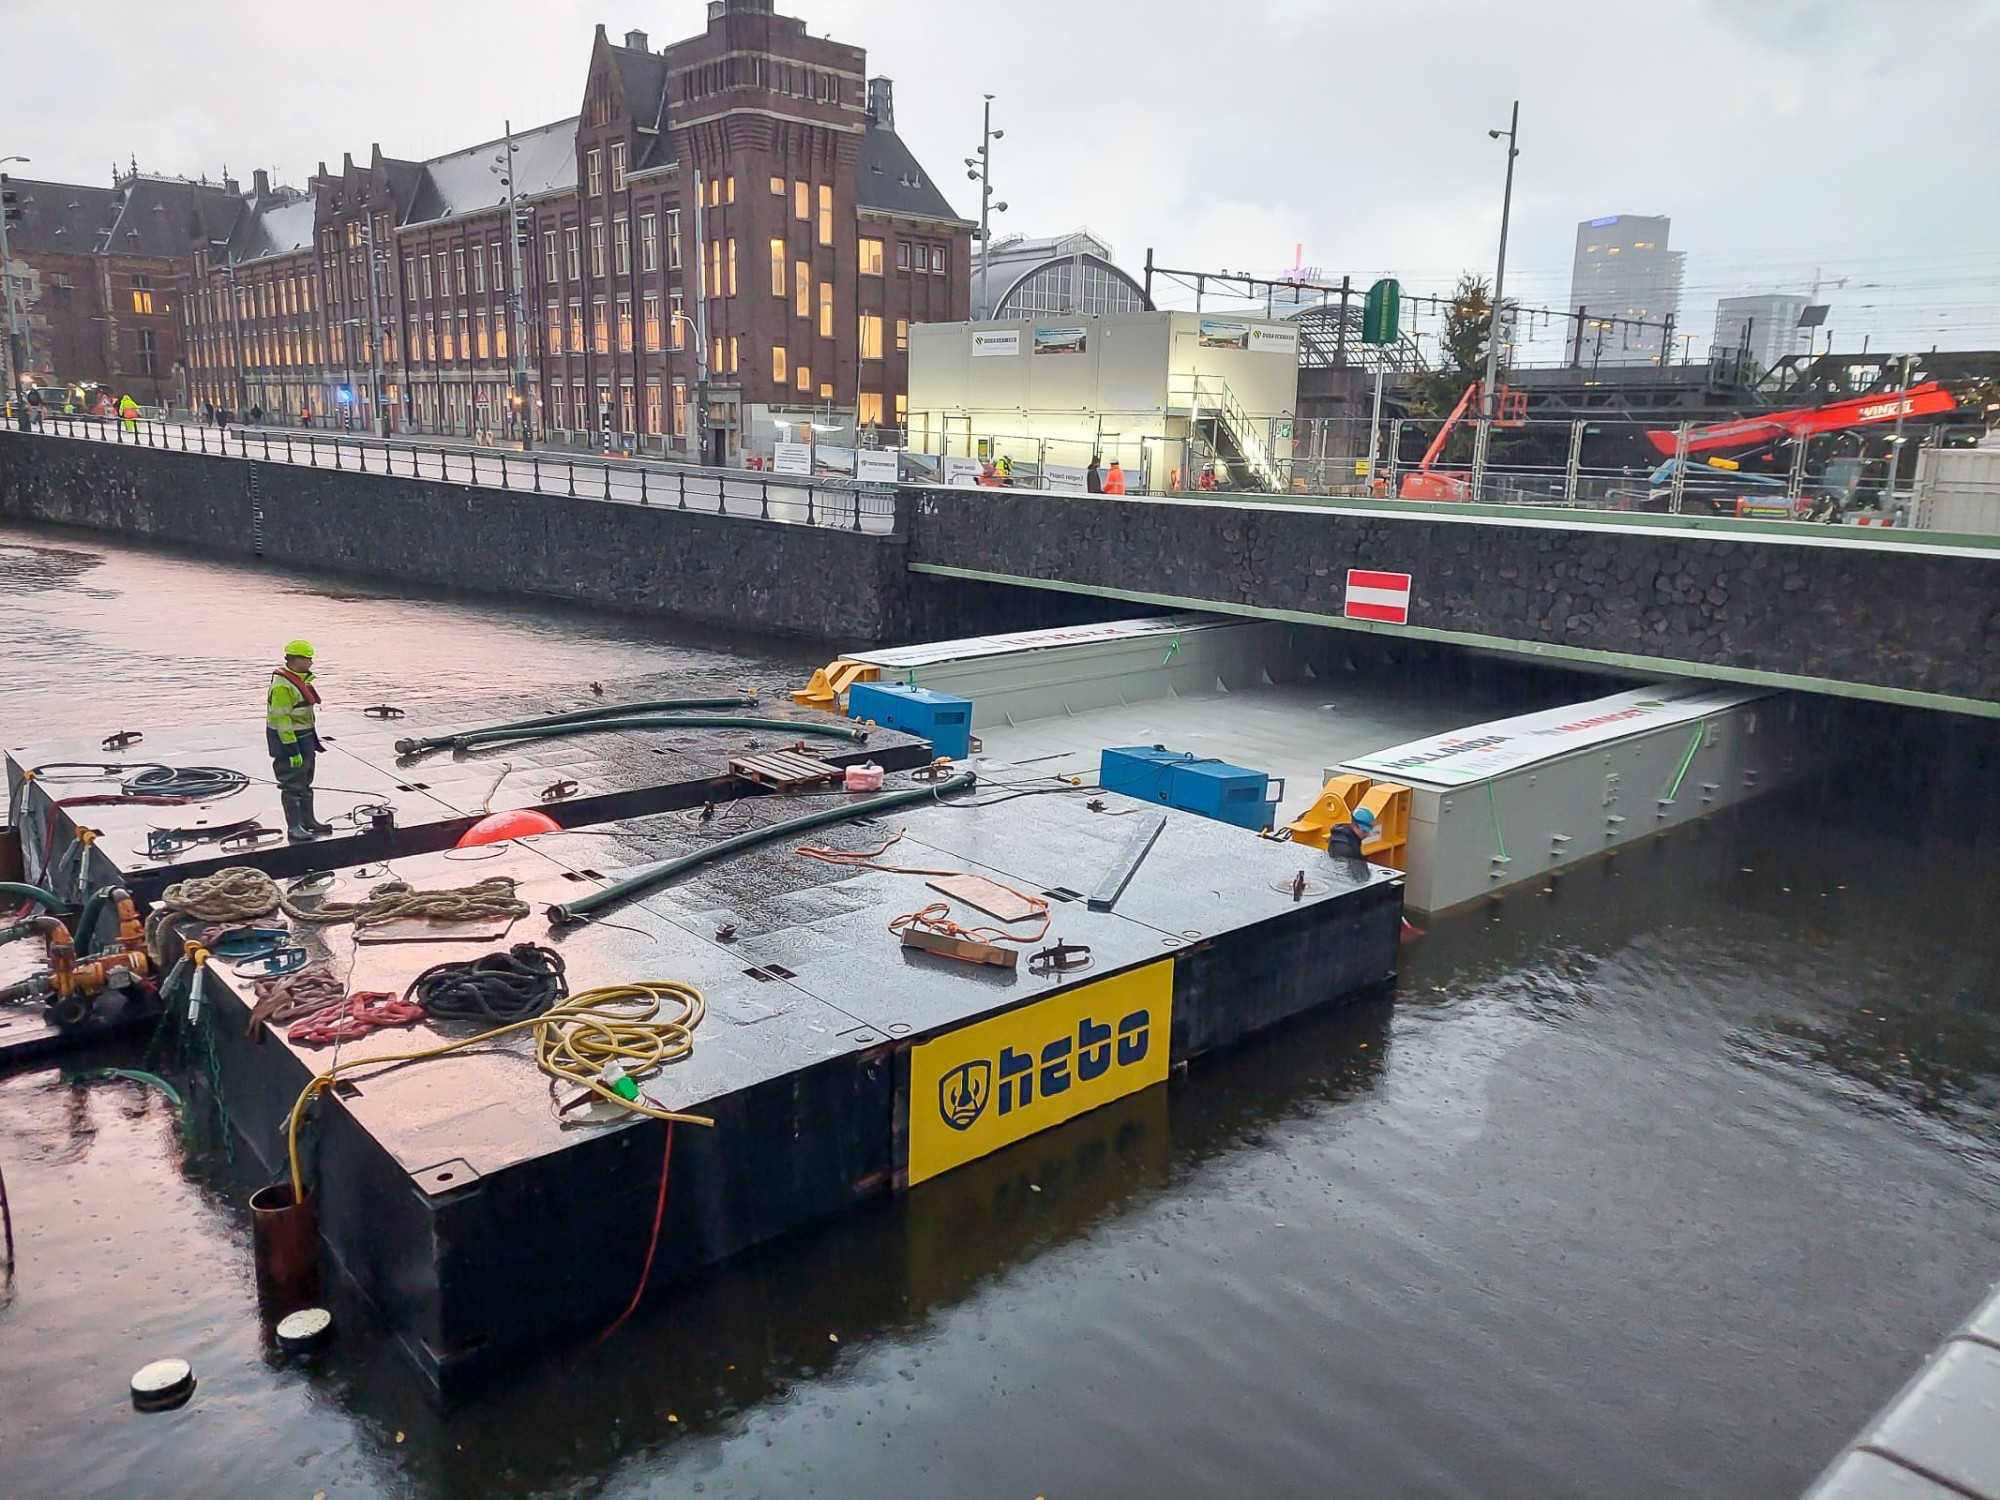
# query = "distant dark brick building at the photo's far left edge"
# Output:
<box><xmin>8</xmin><ymin>170</ymin><xmax>240</xmax><ymax>406</ymax></box>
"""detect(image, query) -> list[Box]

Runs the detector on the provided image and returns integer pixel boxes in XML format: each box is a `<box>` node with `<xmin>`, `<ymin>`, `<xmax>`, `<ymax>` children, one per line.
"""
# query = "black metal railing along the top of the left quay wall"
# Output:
<box><xmin>19</xmin><ymin>412</ymin><xmax>902</xmax><ymax>536</ymax></box>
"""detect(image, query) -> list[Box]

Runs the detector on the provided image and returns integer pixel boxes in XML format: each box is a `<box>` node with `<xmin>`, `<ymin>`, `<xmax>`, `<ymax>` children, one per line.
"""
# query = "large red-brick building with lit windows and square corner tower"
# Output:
<box><xmin>186</xmin><ymin>0</ymin><xmax>972</xmax><ymax>460</ymax></box>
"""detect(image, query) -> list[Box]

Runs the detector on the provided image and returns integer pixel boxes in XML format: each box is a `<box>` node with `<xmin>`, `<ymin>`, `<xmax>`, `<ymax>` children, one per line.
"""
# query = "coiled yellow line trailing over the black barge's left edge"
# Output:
<box><xmin>284</xmin><ymin>980</ymin><xmax>714</xmax><ymax>1204</ymax></box>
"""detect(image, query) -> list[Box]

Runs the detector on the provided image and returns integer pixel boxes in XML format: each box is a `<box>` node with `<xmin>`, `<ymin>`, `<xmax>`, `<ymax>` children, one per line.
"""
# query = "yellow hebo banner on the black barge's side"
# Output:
<box><xmin>910</xmin><ymin>958</ymin><xmax>1174</xmax><ymax>1182</ymax></box>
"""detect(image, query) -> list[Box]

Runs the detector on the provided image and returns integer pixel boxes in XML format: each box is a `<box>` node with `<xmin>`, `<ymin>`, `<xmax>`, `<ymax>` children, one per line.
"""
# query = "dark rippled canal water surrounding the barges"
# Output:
<box><xmin>0</xmin><ymin>530</ymin><xmax>2000</xmax><ymax>1500</ymax></box>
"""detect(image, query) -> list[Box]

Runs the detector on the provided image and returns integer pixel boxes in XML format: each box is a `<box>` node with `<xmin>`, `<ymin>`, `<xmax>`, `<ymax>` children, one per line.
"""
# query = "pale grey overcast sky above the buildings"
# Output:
<box><xmin>0</xmin><ymin>0</ymin><xmax>2000</xmax><ymax>354</ymax></box>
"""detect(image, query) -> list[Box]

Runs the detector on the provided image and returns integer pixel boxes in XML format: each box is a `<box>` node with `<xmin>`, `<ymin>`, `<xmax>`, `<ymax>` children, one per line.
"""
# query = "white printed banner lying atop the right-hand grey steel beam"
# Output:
<box><xmin>1342</xmin><ymin>684</ymin><xmax>1768</xmax><ymax>786</ymax></box>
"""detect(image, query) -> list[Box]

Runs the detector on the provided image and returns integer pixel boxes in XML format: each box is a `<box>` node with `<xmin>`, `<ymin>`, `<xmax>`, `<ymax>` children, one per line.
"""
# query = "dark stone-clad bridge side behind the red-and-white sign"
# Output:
<box><xmin>910</xmin><ymin>490</ymin><xmax>2000</xmax><ymax>702</ymax></box>
